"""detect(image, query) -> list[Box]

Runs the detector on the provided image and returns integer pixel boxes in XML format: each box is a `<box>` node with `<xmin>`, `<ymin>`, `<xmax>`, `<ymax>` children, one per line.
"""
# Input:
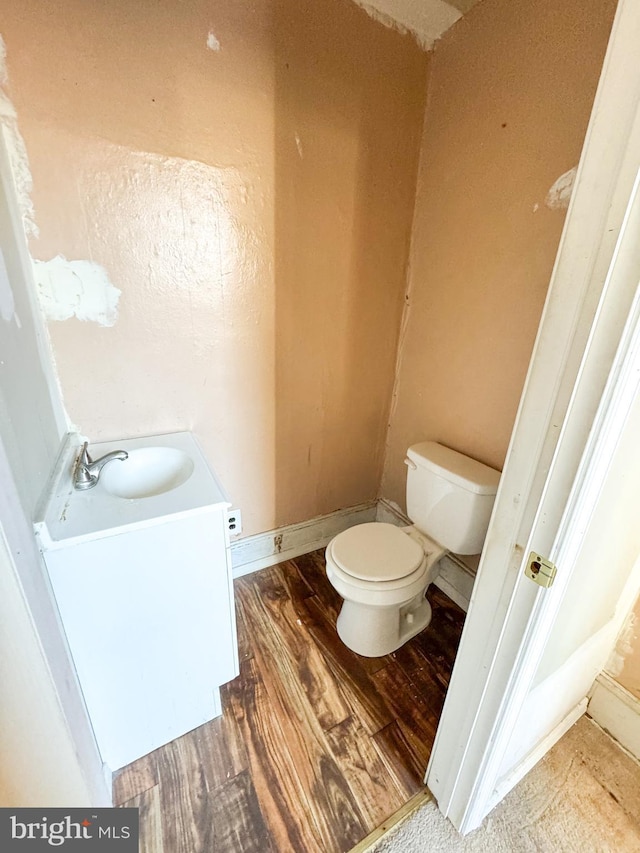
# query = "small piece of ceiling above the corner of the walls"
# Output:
<box><xmin>355</xmin><ymin>0</ymin><xmax>479</xmax><ymax>50</ymax></box>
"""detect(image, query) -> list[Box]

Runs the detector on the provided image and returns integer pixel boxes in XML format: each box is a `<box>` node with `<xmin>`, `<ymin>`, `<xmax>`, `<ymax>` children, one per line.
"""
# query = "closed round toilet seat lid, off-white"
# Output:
<box><xmin>331</xmin><ymin>521</ymin><xmax>425</xmax><ymax>586</ymax></box>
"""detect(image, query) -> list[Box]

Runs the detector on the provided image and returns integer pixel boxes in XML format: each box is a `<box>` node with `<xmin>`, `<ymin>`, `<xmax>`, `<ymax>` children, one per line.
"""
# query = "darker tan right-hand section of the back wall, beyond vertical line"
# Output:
<box><xmin>275</xmin><ymin>2</ymin><xmax>426</xmax><ymax>520</ymax></box>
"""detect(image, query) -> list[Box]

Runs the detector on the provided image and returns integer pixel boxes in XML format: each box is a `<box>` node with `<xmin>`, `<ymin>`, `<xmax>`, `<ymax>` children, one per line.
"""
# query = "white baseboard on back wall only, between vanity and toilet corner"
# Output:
<box><xmin>231</xmin><ymin>501</ymin><xmax>377</xmax><ymax>578</ymax></box>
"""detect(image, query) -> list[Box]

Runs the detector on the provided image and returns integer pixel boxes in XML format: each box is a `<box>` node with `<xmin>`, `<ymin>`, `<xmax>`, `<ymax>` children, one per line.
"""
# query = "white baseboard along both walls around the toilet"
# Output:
<box><xmin>231</xmin><ymin>498</ymin><xmax>475</xmax><ymax>612</ymax></box>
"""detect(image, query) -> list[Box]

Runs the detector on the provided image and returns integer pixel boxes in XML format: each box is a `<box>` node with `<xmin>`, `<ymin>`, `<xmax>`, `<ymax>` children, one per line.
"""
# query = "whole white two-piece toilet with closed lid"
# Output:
<box><xmin>326</xmin><ymin>441</ymin><xmax>500</xmax><ymax>657</ymax></box>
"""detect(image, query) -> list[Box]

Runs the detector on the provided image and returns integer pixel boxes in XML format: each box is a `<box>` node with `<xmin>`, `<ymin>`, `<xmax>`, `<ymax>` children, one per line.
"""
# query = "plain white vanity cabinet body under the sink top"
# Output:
<box><xmin>39</xmin><ymin>433</ymin><xmax>238</xmax><ymax>770</ymax></box>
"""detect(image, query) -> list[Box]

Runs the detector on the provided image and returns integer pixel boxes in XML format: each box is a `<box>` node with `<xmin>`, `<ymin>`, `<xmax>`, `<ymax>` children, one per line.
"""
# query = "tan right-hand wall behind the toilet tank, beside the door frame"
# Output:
<box><xmin>382</xmin><ymin>0</ymin><xmax>616</xmax><ymax>505</ymax></box>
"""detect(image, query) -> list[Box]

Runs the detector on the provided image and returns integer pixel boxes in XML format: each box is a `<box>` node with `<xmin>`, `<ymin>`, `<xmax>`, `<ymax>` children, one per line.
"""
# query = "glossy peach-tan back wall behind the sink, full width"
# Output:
<box><xmin>0</xmin><ymin>0</ymin><xmax>427</xmax><ymax>533</ymax></box>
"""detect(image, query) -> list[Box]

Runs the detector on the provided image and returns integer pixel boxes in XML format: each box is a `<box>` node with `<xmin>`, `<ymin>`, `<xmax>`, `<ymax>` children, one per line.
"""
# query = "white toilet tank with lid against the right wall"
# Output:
<box><xmin>405</xmin><ymin>441</ymin><xmax>500</xmax><ymax>554</ymax></box>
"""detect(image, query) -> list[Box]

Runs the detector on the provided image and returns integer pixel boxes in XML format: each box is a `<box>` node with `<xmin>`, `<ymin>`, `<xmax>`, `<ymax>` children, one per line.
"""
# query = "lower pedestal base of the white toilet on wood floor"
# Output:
<box><xmin>336</xmin><ymin>590</ymin><xmax>431</xmax><ymax>658</ymax></box>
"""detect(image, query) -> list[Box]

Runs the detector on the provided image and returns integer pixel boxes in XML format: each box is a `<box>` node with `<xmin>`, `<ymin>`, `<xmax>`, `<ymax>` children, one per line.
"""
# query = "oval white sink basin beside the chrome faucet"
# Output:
<box><xmin>100</xmin><ymin>447</ymin><xmax>193</xmax><ymax>499</ymax></box>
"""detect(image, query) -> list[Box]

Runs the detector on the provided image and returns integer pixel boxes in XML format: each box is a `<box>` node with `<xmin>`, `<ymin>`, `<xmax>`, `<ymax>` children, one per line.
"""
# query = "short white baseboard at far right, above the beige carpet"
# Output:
<box><xmin>587</xmin><ymin>672</ymin><xmax>640</xmax><ymax>761</ymax></box>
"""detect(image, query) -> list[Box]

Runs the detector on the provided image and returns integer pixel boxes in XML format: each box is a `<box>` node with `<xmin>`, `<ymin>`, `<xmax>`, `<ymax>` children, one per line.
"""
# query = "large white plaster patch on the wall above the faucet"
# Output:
<box><xmin>33</xmin><ymin>255</ymin><xmax>120</xmax><ymax>326</ymax></box>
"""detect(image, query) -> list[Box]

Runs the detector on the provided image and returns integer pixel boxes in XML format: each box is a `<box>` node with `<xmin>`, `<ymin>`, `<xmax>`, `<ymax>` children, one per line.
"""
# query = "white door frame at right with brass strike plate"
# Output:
<box><xmin>426</xmin><ymin>0</ymin><xmax>640</xmax><ymax>832</ymax></box>
